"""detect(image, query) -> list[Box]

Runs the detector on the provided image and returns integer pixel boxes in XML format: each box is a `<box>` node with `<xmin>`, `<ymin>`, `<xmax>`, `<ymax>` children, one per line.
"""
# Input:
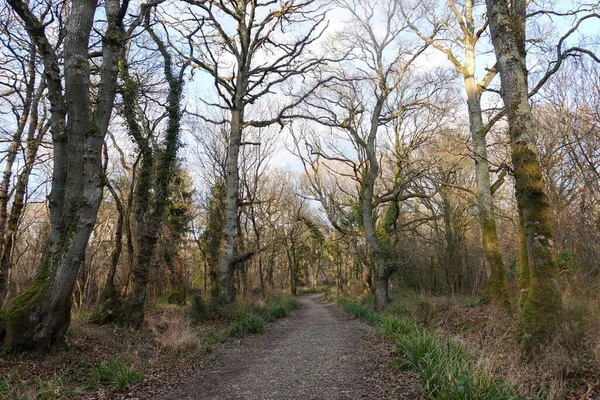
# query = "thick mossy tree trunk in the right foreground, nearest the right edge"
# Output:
<box><xmin>486</xmin><ymin>0</ymin><xmax>562</xmax><ymax>351</ymax></box>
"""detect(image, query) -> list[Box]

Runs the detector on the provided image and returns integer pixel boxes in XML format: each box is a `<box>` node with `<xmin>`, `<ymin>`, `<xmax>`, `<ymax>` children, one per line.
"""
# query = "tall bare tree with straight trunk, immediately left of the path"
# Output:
<box><xmin>186</xmin><ymin>0</ymin><xmax>332</xmax><ymax>302</ymax></box>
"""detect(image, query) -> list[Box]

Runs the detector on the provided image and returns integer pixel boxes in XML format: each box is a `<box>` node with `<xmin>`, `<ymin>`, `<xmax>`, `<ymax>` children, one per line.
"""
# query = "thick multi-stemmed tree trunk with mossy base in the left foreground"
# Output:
<box><xmin>2</xmin><ymin>0</ymin><xmax>126</xmax><ymax>350</ymax></box>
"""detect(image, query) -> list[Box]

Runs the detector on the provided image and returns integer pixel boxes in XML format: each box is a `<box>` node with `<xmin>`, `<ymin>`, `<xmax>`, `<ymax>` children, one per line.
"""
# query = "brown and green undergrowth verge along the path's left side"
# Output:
<box><xmin>0</xmin><ymin>295</ymin><xmax>298</xmax><ymax>400</ymax></box>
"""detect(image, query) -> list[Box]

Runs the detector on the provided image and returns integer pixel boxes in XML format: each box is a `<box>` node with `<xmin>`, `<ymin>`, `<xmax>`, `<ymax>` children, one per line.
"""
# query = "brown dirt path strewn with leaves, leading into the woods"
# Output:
<box><xmin>145</xmin><ymin>294</ymin><xmax>420</xmax><ymax>400</ymax></box>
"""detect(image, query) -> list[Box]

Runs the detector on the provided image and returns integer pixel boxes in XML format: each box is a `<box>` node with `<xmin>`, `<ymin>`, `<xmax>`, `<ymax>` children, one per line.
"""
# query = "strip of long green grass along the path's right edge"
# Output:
<box><xmin>337</xmin><ymin>298</ymin><xmax>524</xmax><ymax>400</ymax></box>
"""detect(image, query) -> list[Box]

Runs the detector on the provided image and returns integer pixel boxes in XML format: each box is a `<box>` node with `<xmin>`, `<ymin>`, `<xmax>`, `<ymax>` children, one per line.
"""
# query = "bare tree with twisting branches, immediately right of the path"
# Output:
<box><xmin>296</xmin><ymin>1</ymin><xmax>446</xmax><ymax>309</ymax></box>
